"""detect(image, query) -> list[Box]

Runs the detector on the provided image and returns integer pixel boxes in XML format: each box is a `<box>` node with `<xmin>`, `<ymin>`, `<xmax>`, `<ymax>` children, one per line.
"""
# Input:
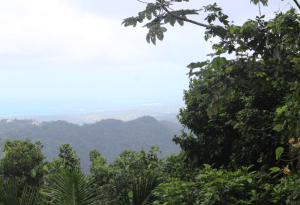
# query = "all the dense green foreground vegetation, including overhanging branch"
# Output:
<box><xmin>0</xmin><ymin>0</ymin><xmax>300</xmax><ymax>205</ymax></box>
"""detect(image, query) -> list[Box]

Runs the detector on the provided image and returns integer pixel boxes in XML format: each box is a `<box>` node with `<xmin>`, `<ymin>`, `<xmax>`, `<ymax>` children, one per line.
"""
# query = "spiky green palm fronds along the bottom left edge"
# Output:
<box><xmin>0</xmin><ymin>167</ymin><xmax>98</xmax><ymax>205</ymax></box>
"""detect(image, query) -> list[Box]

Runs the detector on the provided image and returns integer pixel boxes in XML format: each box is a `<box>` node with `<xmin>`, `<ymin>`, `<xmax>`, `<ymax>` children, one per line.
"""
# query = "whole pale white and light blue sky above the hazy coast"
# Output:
<box><xmin>0</xmin><ymin>0</ymin><xmax>298</xmax><ymax>116</ymax></box>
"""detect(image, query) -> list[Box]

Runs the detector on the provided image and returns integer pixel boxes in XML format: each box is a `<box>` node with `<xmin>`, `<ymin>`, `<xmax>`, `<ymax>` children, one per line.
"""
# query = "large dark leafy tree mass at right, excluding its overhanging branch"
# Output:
<box><xmin>169</xmin><ymin>3</ymin><xmax>299</xmax><ymax>174</ymax></box>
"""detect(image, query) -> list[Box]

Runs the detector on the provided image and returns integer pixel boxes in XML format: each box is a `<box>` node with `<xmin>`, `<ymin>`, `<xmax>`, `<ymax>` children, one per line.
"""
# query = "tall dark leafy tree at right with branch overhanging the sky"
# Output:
<box><xmin>122</xmin><ymin>0</ymin><xmax>300</xmax><ymax>204</ymax></box>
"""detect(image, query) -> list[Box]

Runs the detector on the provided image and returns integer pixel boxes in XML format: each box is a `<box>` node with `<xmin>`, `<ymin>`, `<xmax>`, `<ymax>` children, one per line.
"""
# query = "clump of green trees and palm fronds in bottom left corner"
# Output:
<box><xmin>0</xmin><ymin>141</ymin><xmax>102</xmax><ymax>204</ymax></box>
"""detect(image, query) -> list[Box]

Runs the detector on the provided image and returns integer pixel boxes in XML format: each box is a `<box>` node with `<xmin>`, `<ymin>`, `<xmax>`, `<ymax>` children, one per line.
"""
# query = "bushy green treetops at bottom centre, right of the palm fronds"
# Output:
<box><xmin>84</xmin><ymin>146</ymin><xmax>191</xmax><ymax>205</ymax></box>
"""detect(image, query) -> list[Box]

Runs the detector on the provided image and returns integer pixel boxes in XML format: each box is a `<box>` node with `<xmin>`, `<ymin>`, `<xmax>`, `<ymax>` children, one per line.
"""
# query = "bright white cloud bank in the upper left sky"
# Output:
<box><xmin>0</xmin><ymin>0</ymin><xmax>147</xmax><ymax>69</ymax></box>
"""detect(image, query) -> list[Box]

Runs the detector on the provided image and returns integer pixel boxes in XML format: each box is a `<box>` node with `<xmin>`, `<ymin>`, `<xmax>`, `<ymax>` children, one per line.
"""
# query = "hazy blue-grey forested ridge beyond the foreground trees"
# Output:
<box><xmin>0</xmin><ymin>116</ymin><xmax>189</xmax><ymax>173</ymax></box>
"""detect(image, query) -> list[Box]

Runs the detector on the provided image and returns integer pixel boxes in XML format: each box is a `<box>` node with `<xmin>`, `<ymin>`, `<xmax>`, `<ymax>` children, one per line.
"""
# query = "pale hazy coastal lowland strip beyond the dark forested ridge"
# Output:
<box><xmin>0</xmin><ymin>101</ymin><xmax>184</xmax><ymax>125</ymax></box>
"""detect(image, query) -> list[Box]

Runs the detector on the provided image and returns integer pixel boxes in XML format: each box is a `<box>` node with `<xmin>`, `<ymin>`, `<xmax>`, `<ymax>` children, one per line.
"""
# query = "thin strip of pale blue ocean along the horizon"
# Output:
<box><xmin>0</xmin><ymin>99</ymin><xmax>184</xmax><ymax>119</ymax></box>
